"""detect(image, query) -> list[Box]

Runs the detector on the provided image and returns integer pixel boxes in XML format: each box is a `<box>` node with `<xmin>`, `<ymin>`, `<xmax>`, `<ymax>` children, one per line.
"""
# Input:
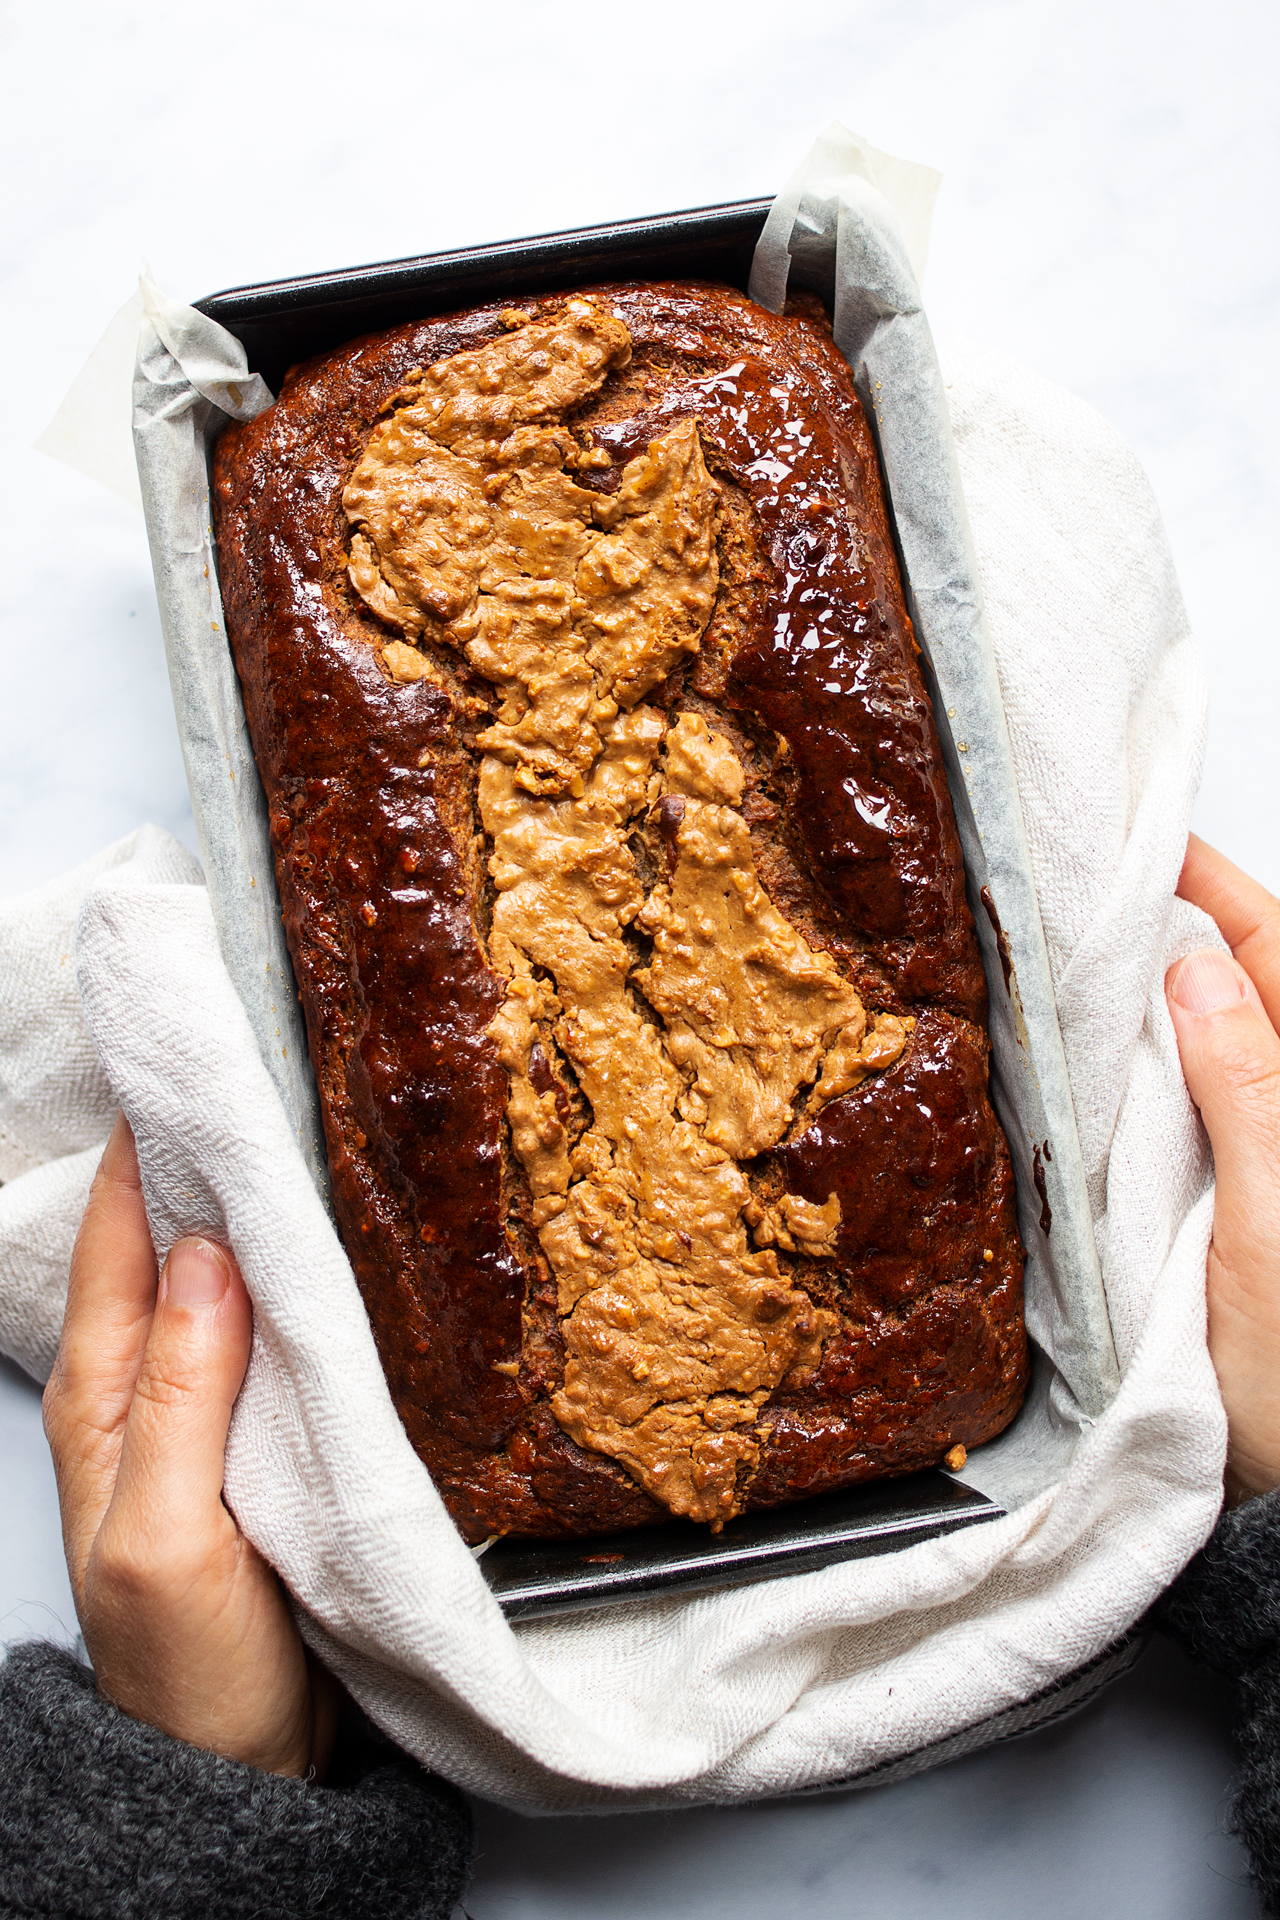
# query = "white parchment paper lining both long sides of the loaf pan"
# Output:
<box><xmin>134</xmin><ymin>129</ymin><xmax>1119</xmax><ymax>1509</ymax></box>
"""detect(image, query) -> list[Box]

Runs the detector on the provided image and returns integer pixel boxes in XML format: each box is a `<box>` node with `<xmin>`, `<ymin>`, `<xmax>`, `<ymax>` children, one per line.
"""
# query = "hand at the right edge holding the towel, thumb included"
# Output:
<box><xmin>1165</xmin><ymin>833</ymin><xmax>1280</xmax><ymax>1505</ymax></box>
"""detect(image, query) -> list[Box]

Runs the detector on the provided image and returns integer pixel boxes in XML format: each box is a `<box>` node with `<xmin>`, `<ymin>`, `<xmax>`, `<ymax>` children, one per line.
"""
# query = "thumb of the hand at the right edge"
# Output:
<box><xmin>1167</xmin><ymin>948</ymin><xmax>1280</xmax><ymax>1292</ymax></box>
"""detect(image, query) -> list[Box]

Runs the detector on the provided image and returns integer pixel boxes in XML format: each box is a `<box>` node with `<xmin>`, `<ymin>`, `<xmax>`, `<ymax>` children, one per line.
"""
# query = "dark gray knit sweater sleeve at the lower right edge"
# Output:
<box><xmin>1157</xmin><ymin>1490</ymin><xmax>1280</xmax><ymax>1914</ymax></box>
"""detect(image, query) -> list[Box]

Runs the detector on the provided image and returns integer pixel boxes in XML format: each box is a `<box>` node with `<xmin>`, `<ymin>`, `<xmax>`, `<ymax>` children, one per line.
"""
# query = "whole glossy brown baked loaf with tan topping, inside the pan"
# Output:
<box><xmin>215</xmin><ymin>284</ymin><xmax>1027</xmax><ymax>1542</ymax></box>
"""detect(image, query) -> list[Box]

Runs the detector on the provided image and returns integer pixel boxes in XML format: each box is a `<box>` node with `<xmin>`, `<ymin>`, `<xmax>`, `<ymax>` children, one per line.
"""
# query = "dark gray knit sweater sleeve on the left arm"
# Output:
<box><xmin>0</xmin><ymin>1645</ymin><xmax>470</xmax><ymax>1920</ymax></box>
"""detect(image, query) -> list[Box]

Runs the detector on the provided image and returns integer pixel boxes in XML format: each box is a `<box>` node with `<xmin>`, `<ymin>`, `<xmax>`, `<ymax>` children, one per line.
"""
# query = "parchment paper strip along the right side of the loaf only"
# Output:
<box><xmin>750</xmin><ymin>127</ymin><xmax>1119</xmax><ymax>1466</ymax></box>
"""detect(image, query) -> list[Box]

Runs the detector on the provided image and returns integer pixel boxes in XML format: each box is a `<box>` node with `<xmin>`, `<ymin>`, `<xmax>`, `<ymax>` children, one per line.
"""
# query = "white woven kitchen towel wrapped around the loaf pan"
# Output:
<box><xmin>0</xmin><ymin>337</ymin><xmax>1224</xmax><ymax>1811</ymax></box>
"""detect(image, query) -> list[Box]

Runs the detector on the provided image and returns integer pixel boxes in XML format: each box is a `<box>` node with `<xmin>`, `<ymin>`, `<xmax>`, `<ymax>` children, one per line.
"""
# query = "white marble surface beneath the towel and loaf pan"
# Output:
<box><xmin>0</xmin><ymin>0</ymin><xmax>1280</xmax><ymax>1920</ymax></box>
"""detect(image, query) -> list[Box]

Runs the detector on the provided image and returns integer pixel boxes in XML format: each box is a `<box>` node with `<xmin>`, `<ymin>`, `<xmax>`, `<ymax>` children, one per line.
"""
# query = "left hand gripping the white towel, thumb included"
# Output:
<box><xmin>44</xmin><ymin>1116</ymin><xmax>338</xmax><ymax>1776</ymax></box>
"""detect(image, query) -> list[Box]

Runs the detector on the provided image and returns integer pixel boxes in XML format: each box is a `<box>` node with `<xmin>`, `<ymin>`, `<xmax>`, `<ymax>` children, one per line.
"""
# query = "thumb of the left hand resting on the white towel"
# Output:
<box><xmin>107</xmin><ymin>1238</ymin><xmax>253</xmax><ymax>1574</ymax></box>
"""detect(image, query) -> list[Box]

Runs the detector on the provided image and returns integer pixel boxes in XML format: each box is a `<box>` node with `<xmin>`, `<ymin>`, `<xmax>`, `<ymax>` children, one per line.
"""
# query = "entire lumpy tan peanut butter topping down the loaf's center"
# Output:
<box><xmin>344</xmin><ymin>300</ymin><xmax>910</xmax><ymax>1524</ymax></box>
